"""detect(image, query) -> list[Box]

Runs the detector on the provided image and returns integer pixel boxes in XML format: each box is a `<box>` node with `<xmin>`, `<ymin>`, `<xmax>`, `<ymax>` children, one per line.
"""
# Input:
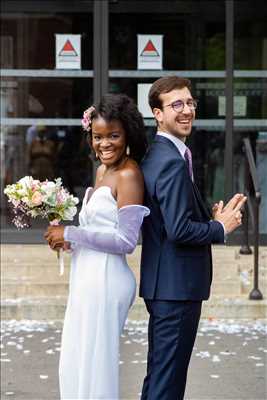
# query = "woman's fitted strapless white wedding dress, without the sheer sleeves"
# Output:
<box><xmin>59</xmin><ymin>186</ymin><xmax>139</xmax><ymax>400</ymax></box>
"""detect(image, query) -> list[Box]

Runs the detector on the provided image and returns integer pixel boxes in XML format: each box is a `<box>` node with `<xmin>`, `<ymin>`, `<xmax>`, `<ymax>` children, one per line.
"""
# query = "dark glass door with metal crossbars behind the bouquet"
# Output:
<box><xmin>0</xmin><ymin>2</ymin><xmax>94</xmax><ymax>241</ymax></box>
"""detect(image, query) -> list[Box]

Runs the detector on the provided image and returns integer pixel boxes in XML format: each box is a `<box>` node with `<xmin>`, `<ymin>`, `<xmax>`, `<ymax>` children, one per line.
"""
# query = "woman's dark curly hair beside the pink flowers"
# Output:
<box><xmin>89</xmin><ymin>94</ymin><xmax>148</xmax><ymax>163</ymax></box>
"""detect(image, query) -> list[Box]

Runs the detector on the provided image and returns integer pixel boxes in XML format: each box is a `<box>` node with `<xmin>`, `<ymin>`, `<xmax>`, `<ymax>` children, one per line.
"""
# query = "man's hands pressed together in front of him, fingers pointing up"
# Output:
<box><xmin>215</xmin><ymin>193</ymin><xmax>247</xmax><ymax>233</ymax></box>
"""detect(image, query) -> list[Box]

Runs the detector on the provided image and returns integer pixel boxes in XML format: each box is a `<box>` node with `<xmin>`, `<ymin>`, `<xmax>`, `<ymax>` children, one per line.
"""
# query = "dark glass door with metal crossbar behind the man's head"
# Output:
<box><xmin>109</xmin><ymin>1</ymin><xmax>228</xmax><ymax>203</ymax></box>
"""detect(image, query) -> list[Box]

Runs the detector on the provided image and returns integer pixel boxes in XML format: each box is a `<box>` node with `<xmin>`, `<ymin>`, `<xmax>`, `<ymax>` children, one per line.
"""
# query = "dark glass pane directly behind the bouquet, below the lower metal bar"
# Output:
<box><xmin>1</xmin><ymin>125</ymin><xmax>94</xmax><ymax>227</ymax></box>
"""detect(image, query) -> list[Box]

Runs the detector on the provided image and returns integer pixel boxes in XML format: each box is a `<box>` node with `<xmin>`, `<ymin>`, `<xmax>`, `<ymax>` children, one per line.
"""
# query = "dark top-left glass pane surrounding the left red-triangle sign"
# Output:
<box><xmin>1</xmin><ymin>13</ymin><xmax>93</xmax><ymax>69</ymax></box>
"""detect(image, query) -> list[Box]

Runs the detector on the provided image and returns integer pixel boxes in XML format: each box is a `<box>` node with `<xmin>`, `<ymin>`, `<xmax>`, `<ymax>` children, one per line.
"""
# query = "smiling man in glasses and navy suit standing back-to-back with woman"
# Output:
<box><xmin>140</xmin><ymin>76</ymin><xmax>246</xmax><ymax>400</ymax></box>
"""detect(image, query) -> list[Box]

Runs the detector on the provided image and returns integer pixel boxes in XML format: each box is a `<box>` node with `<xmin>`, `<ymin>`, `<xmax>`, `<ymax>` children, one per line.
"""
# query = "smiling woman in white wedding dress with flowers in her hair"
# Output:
<box><xmin>45</xmin><ymin>94</ymin><xmax>149</xmax><ymax>400</ymax></box>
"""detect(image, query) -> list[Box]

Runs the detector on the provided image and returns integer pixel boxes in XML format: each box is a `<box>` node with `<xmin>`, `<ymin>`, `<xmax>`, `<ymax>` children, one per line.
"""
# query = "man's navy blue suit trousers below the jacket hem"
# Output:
<box><xmin>141</xmin><ymin>300</ymin><xmax>202</xmax><ymax>400</ymax></box>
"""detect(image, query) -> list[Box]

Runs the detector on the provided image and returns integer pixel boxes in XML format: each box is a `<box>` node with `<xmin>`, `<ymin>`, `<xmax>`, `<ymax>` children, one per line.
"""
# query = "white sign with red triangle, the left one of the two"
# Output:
<box><xmin>56</xmin><ymin>34</ymin><xmax>81</xmax><ymax>69</ymax></box>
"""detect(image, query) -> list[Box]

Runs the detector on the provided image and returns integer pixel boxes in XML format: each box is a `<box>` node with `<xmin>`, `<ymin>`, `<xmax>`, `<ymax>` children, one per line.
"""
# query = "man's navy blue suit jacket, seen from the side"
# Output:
<box><xmin>140</xmin><ymin>135</ymin><xmax>224</xmax><ymax>300</ymax></box>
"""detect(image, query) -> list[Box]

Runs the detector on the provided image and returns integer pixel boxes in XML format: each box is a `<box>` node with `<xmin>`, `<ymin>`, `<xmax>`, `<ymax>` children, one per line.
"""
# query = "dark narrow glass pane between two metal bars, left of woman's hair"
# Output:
<box><xmin>1</xmin><ymin>78</ymin><xmax>93</xmax><ymax>118</ymax></box>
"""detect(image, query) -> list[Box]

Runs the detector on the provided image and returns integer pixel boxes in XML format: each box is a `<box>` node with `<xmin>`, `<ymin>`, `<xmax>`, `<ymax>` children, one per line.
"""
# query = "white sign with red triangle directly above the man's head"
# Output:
<box><xmin>137</xmin><ymin>35</ymin><xmax>163</xmax><ymax>69</ymax></box>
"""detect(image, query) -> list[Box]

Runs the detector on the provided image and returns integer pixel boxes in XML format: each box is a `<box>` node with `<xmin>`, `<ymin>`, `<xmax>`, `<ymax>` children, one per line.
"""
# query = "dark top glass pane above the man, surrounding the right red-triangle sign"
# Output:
<box><xmin>109</xmin><ymin>1</ymin><xmax>225</xmax><ymax>70</ymax></box>
